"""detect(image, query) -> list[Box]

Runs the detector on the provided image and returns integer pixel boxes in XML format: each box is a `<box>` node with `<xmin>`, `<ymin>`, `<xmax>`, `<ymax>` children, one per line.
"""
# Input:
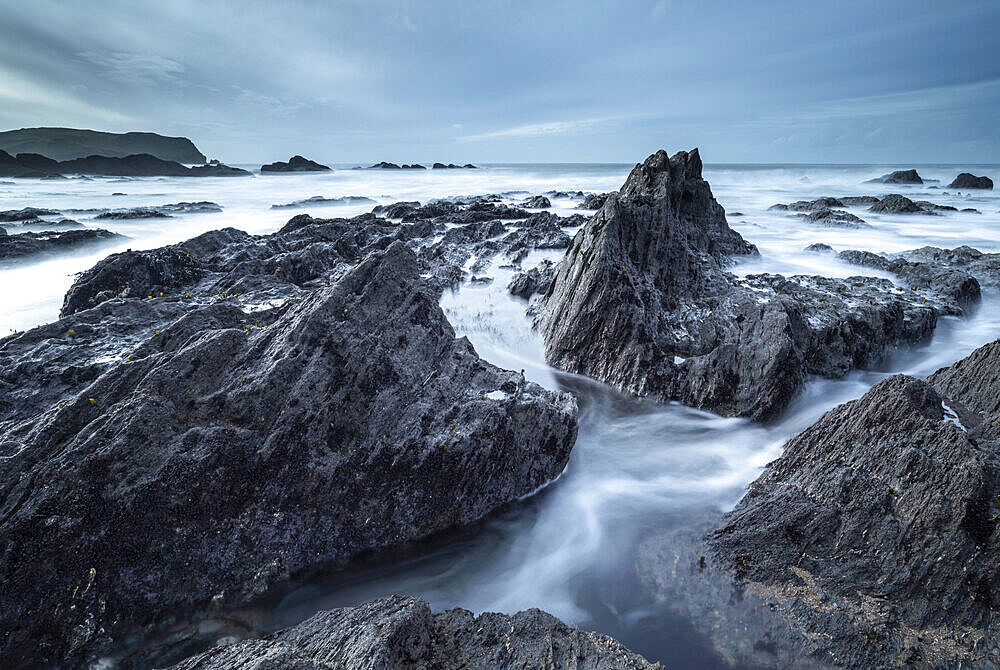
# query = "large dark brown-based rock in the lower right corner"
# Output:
<box><xmin>710</xmin><ymin>341</ymin><xmax>1000</xmax><ymax>668</ymax></box>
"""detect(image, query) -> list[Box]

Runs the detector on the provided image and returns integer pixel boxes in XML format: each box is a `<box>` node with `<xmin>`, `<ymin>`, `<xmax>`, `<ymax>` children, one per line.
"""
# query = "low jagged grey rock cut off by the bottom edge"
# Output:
<box><xmin>171</xmin><ymin>596</ymin><xmax>662</xmax><ymax>670</ymax></box>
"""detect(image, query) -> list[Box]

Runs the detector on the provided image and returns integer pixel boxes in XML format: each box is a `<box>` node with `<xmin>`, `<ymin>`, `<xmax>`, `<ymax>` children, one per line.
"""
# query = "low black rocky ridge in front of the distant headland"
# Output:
<box><xmin>0</xmin><ymin>150</ymin><xmax>250</xmax><ymax>179</ymax></box>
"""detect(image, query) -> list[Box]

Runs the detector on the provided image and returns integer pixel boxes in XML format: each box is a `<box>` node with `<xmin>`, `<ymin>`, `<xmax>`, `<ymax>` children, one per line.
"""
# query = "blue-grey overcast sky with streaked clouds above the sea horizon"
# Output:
<box><xmin>0</xmin><ymin>0</ymin><xmax>1000</xmax><ymax>163</ymax></box>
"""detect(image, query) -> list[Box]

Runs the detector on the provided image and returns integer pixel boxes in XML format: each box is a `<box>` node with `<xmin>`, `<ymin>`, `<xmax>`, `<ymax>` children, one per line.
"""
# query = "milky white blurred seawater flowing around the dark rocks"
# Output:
<box><xmin>0</xmin><ymin>164</ymin><xmax>1000</xmax><ymax>670</ymax></box>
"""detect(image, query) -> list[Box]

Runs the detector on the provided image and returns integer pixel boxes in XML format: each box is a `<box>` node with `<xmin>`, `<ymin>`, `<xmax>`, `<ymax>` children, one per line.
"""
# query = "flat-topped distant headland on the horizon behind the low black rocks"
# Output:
<box><xmin>0</xmin><ymin>128</ymin><xmax>206</xmax><ymax>164</ymax></box>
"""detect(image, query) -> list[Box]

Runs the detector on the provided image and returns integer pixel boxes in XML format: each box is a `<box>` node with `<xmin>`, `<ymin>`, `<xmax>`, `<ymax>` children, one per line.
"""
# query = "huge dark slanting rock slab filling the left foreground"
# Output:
<box><xmin>0</xmin><ymin>240</ymin><xmax>576</xmax><ymax>665</ymax></box>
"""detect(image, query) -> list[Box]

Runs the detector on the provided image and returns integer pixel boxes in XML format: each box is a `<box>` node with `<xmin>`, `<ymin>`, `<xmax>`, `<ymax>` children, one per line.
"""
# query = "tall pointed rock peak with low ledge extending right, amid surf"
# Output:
<box><xmin>536</xmin><ymin>150</ymin><xmax>974</xmax><ymax>419</ymax></box>
